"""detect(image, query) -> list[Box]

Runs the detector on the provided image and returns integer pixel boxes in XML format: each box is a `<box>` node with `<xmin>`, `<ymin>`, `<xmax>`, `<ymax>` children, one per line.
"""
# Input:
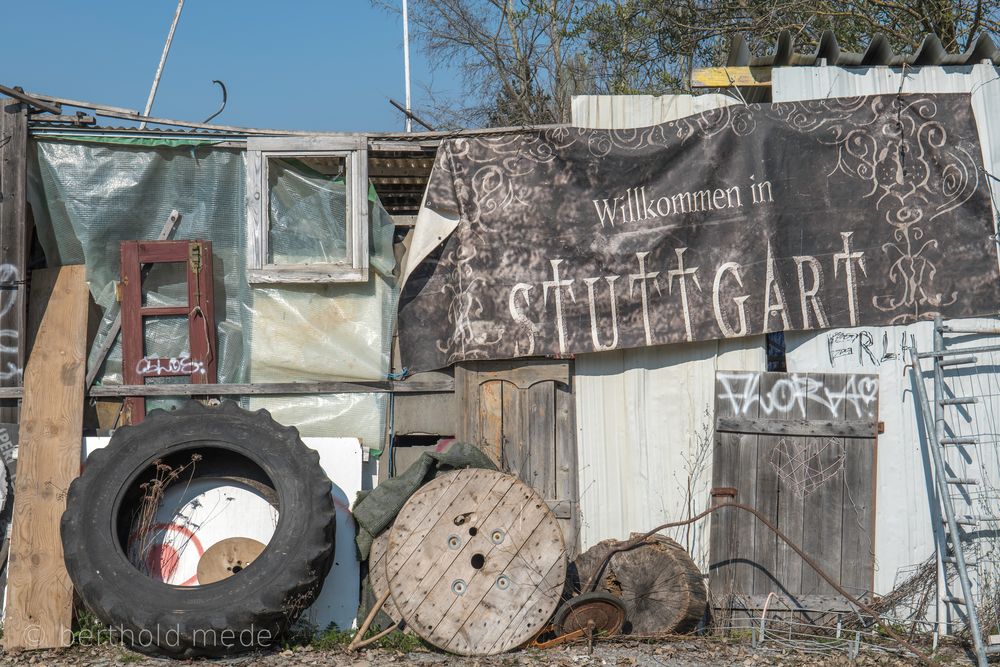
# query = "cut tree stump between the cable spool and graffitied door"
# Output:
<box><xmin>571</xmin><ymin>535</ymin><xmax>707</xmax><ymax>635</ymax></box>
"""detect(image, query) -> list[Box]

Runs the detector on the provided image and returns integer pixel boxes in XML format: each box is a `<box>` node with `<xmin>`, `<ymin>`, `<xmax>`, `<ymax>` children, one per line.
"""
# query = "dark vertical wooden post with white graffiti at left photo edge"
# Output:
<box><xmin>0</xmin><ymin>99</ymin><xmax>29</xmax><ymax>424</ymax></box>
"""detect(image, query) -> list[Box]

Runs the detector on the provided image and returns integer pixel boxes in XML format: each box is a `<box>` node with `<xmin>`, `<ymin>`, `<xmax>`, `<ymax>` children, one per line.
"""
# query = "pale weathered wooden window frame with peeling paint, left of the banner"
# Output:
<box><xmin>246</xmin><ymin>135</ymin><xmax>368</xmax><ymax>284</ymax></box>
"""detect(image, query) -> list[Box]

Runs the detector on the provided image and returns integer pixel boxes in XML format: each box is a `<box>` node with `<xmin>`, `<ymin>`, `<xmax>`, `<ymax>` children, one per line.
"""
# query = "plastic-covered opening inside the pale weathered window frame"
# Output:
<box><xmin>267</xmin><ymin>156</ymin><xmax>349</xmax><ymax>264</ymax></box>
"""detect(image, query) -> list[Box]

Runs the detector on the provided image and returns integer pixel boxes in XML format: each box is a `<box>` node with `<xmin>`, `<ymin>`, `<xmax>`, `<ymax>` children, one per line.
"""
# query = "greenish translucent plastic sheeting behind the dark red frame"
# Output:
<box><xmin>29</xmin><ymin>140</ymin><xmax>250</xmax><ymax>392</ymax></box>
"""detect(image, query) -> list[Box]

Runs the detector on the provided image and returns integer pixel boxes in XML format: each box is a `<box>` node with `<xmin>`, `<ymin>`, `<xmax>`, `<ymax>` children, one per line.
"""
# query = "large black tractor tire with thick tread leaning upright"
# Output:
<box><xmin>61</xmin><ymin>401</ymin><xmax>335</xmax><ymax>659</ymax></box>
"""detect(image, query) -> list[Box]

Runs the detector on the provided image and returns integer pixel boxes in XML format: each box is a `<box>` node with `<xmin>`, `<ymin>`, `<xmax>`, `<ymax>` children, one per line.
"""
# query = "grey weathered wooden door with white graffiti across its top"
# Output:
<box><xmin>709</xmin><ymin>371</ymin><xmax>878</xmax><ymax>610</ymax></box>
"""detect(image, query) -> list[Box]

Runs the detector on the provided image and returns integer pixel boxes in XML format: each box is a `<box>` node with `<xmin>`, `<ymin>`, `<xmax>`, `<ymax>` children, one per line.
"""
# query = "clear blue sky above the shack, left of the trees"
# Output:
<box><xmin>0</xmin><ymin>0</ymin><xmax>457</xmax><ymax>131</ymax></box>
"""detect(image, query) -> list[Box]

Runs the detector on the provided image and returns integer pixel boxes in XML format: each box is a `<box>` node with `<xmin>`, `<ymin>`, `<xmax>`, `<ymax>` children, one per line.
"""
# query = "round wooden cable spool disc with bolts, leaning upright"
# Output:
<box><xmin>386</xmin><ymin>469</ymin><xmax>567</xmax><ymax>655</ymax></box>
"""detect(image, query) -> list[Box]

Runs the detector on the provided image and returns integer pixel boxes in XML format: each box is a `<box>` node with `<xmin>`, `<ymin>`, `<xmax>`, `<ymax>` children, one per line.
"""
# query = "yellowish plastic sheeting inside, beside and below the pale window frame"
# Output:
<box><xmin>249</xmin><ymin>166</ymin><xmax>397</xmax><ymax>452</ymax></box>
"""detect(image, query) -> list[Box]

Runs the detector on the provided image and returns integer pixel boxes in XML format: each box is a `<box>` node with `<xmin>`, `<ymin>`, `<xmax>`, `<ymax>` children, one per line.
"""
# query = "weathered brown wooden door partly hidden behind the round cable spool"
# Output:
<box><xmin>455</xmin><ymin>360</ymin><xmax>579</xmax><ymax>556</ymax></box>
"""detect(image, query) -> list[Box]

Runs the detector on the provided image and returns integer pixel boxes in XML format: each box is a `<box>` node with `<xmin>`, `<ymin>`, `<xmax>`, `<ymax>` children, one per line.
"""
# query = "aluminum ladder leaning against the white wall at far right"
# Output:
<box><xmin>910</xmin><ymin>316</ymin><xmax>1000</xmax><ymax>667</ymax></box>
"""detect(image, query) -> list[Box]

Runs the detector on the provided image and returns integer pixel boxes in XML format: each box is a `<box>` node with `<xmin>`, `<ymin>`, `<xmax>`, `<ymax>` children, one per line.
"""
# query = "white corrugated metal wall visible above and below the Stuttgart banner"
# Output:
<box><xmin>573</xmin><ymin>65</ymin><xmax>1000</xmax><ymax>593</ymax></box>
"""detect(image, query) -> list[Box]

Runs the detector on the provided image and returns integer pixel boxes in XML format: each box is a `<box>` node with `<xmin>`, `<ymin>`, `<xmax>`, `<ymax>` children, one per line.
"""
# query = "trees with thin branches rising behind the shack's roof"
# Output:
<box><xmin>382</xmin><ymin>0</ymin><xmax>1000</xmax><ymax>127</ymax></box>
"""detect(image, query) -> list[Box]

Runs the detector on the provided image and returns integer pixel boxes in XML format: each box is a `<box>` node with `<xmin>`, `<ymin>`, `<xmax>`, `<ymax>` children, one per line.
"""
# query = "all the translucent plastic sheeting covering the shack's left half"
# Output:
<box><xmin>29</xmin><ymin>140</ymin><xmax>397</xmax><ymax>450</ymax></box>
